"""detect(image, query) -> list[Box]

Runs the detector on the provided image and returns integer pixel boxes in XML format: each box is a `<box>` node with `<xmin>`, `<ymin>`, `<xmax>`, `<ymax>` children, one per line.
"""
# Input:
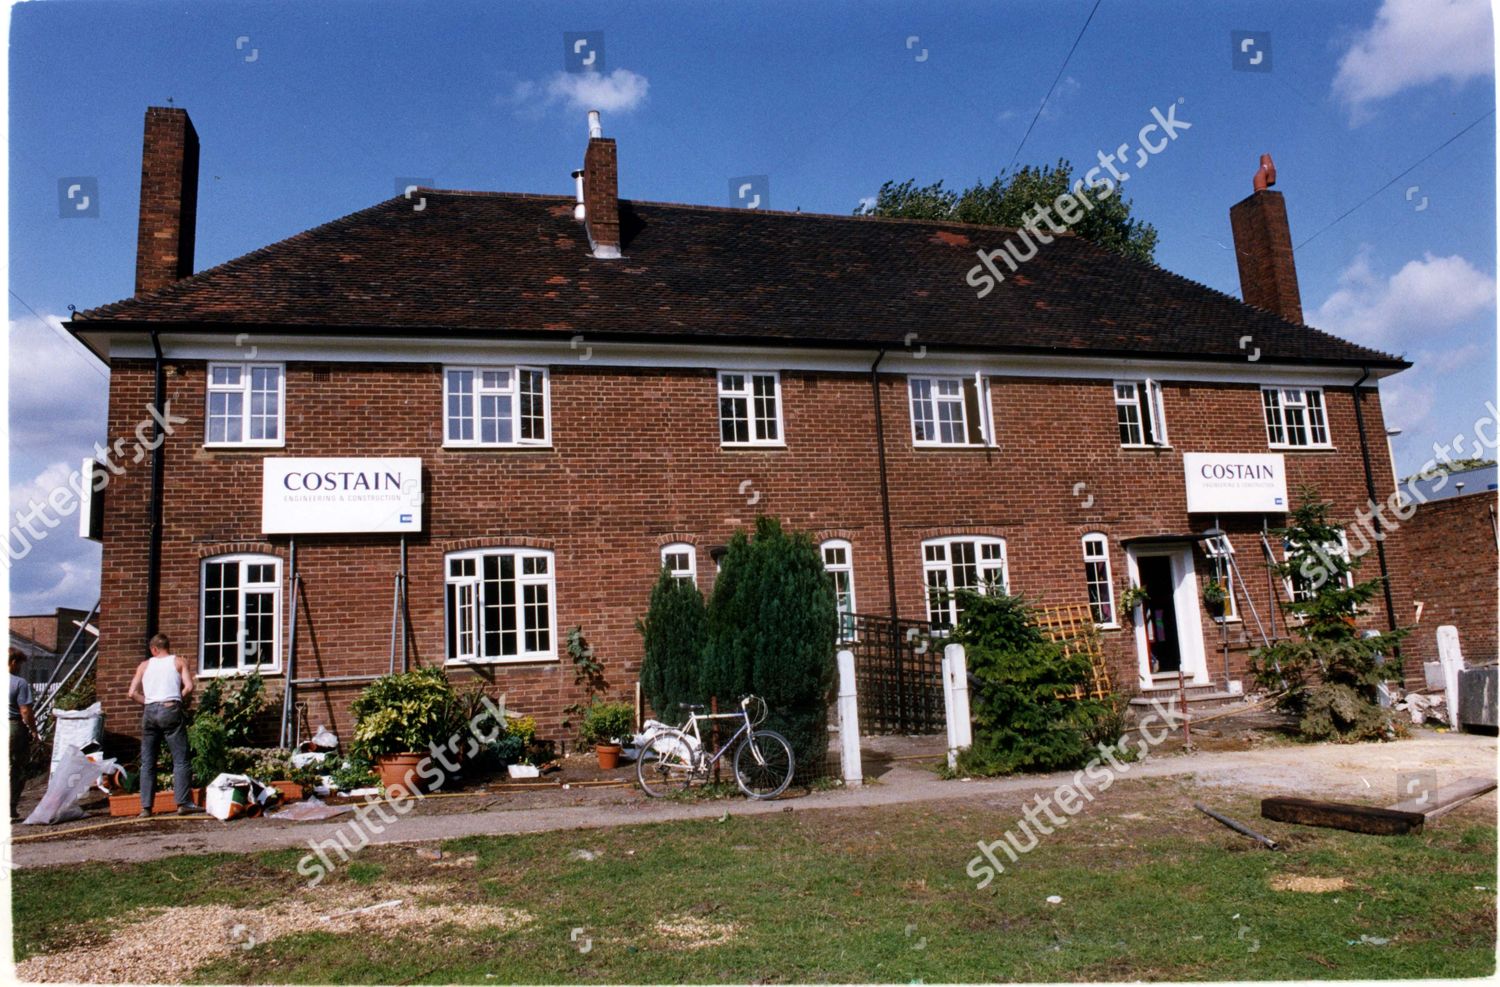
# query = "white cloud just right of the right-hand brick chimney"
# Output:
<box><xmin>1308</xmin><ymin>249</ymin><xmax>1496</xmax><ymax>353</ymax></box>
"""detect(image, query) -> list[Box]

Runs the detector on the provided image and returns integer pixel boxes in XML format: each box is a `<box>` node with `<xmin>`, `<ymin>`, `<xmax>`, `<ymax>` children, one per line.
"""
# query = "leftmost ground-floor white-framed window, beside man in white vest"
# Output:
<box><xmin>198</xmin><ymin>554</ymin><xmax>282</xmax><ymax>675</ymax></box>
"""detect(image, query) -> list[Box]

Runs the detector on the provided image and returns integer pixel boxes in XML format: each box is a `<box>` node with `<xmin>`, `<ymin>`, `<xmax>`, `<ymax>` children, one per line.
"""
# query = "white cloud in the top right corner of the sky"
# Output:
<box><xmin>1334</xmin><ymin>0</ymin><xmax>1494</xmax><ymax>123</ymax></box>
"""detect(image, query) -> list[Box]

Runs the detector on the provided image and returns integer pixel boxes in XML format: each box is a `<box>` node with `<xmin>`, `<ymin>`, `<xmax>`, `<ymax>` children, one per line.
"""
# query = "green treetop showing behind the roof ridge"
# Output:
<box><xmin>855</xmin><ymin>159</ymin><xmax>1157</xmax><ymax>264</ymax></box>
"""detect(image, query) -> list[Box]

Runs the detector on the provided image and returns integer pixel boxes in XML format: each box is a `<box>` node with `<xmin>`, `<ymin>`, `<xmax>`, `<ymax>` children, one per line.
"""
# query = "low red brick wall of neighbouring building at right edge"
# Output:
<box><xmin>1389</xmin><ymin>494</ymin><xmax>1500</xmax><ymax>675</ymax></box>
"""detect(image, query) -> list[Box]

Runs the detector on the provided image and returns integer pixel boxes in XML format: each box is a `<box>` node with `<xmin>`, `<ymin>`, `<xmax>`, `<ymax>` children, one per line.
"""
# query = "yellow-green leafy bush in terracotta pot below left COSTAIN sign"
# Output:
<box><xmin>351</xmin><ymin>668</ymin><xmax>461</xmax><ymax>792</ymax></box>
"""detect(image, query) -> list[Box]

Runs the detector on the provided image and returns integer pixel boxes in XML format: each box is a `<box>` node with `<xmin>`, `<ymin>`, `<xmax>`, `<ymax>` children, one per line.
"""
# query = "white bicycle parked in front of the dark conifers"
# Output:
<box><xmin>636</xmin><ymin>696</ymin><xmax>795</xmax><ymax>800</ymax></box>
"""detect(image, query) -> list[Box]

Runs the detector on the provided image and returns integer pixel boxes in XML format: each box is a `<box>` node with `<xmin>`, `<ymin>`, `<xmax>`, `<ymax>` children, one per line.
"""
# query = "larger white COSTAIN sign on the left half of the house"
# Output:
<box><xmin>261</xmin><ymin>458</ymin><xmax>422</xmax><ymax>534</ymax></box>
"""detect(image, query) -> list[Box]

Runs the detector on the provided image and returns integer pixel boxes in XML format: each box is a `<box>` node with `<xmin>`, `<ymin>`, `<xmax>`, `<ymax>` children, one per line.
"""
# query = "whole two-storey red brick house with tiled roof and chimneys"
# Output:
<box><xmin>69</xmin><ymin>108</ymin><xmax>1407</xmax><ymax>747</ymax></box>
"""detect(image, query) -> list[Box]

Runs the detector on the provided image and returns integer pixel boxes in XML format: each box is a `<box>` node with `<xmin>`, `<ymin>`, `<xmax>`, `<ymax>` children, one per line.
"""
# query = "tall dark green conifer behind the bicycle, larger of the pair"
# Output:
<box><xmin>704</xmin><ymin>518</ymin><xmax>839</xmax><ymax>771</ymax></box>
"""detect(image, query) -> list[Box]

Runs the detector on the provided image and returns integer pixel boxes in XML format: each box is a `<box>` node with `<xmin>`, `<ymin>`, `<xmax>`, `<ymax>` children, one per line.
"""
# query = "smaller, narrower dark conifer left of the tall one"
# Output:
<box><xmin>636</xmin><ymin>569</ymin><xmax>708</xmax><ymax>723</ymax></box>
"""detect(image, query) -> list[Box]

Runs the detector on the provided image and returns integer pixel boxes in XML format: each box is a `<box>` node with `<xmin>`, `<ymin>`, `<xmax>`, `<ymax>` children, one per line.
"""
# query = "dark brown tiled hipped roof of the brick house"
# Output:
<box><xmin>74</xmin><ymin>189</ymin><xmax>1404</xmax><ymax>368</ymax></box>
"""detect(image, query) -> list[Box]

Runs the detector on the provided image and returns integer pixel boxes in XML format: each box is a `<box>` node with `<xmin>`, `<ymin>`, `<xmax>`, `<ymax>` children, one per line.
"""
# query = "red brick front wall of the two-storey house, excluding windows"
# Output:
<box><xmin>99</xmin><ymin>360</ymin><xmax>1407</xmax><ymax>750</ymax></box>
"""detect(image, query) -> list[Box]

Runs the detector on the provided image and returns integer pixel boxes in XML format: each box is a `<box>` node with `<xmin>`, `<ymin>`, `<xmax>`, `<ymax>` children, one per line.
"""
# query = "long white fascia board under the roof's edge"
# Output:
<box><xmin>90</xmin><ymin>332</ymin><xmax>1397</xmax><ymax>390</ymax></box>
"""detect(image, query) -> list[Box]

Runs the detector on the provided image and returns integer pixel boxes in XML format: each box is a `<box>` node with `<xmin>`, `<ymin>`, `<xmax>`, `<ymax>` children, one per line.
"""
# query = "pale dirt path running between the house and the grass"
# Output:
<box><xmin>12</xmin><ymin>732</ymin><xmax>1497</xmax><ymax>867</ymax></box>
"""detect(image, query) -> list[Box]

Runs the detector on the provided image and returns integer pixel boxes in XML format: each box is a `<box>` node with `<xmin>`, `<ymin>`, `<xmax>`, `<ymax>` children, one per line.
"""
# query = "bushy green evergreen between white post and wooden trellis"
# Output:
<box><xmin>950</xmin><ymin>591</ymin><xmax>1119</xmax><ymax>774</ymax></box>
